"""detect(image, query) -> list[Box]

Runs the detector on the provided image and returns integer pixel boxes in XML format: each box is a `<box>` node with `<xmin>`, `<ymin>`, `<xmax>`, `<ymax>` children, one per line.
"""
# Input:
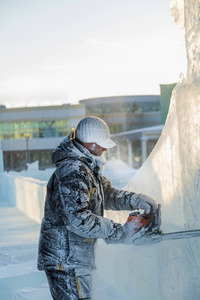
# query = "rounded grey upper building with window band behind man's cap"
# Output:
<box><xmin>80</xmin><ymin>95</ymin><xmax>161</xmax><ymax>134</ymax></box>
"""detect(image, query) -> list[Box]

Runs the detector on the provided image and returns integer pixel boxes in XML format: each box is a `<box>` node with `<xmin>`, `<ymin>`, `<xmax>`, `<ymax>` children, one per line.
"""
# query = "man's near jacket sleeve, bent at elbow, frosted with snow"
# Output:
<box><xmin>55</xmin><ymin>164</ymin><xmax>123</xmax><ymax>239</ymax></box>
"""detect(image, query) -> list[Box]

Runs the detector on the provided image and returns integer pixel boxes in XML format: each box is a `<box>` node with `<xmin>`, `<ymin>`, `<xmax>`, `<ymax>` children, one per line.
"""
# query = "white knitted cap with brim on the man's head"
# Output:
<box><xmin>75</xmin><ymin>117</ymin><xmax>116</xmax><ymax>148</ymax></box>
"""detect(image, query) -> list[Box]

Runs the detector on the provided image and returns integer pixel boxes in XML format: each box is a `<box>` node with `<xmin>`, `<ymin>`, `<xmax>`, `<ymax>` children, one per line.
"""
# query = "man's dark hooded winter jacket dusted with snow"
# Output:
<box><xmin>38</xmin><ymin>133</ymin><xmax>138</xmax><ymax>270</ymax></box>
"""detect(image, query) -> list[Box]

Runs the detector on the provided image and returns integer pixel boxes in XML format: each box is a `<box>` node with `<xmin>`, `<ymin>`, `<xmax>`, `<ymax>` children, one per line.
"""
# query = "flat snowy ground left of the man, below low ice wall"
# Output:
<box><xmin>0</xmin><ymin>203</ymin><xmax>50</xmax><ymax>300</ymax></box>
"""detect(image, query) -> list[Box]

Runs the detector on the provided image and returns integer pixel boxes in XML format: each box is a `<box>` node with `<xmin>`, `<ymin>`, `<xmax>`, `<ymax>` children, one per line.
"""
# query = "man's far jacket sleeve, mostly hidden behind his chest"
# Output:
<box><xmin>101</xmin><ymin>176</ymin><xmax>142</xmax><ymax>210</ymax></box>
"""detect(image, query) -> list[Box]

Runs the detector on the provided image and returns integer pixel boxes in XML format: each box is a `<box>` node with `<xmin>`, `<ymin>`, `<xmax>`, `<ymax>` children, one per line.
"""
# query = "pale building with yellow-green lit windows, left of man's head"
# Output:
<box><xmin>0</xmin><ymin>104</ymin><xmax>85</xmax><ymax>171</ymax></box>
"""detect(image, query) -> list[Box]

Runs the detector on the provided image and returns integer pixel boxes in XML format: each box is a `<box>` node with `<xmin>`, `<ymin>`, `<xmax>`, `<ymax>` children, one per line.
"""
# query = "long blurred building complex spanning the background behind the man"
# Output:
<box><xmin>0</xmin><ymin>95</ymin><xmax>173</xmax><ymax>171</ymax></box>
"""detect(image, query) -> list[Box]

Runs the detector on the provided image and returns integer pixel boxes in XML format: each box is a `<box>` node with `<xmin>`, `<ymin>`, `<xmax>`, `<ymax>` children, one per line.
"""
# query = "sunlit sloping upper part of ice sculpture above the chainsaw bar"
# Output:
<box><xmin>128</xmin><ymin>0</ymin><xmax>200</xmax><ymax>228</ymax></box>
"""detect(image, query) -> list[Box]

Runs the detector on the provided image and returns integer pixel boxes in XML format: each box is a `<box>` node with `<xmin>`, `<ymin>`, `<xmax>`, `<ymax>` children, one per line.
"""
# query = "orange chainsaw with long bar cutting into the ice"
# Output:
<box><xmin>128</xmin><ymin>212</ymin><xmax>200</xmax><ymax>245</ymax></box>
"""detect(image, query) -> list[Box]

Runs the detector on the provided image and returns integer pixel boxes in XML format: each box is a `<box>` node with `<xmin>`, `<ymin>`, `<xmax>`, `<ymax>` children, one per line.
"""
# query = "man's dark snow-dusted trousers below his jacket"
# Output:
<box><xmin>45</xmin><ymin>269</ymin><xmax>91</xmax><ymax>300</ymax></box>
